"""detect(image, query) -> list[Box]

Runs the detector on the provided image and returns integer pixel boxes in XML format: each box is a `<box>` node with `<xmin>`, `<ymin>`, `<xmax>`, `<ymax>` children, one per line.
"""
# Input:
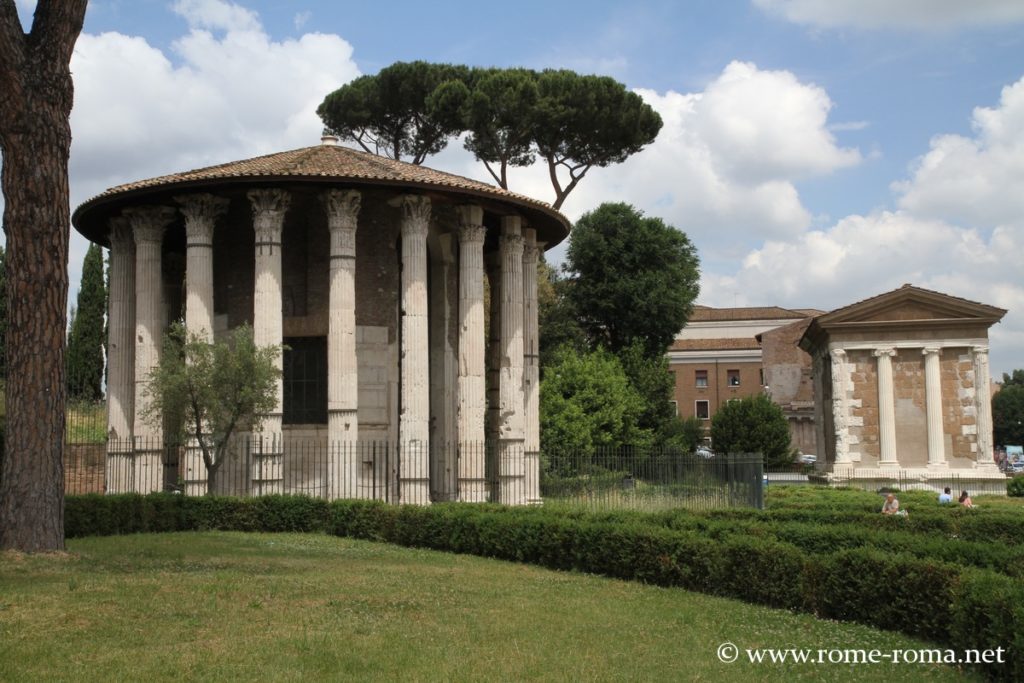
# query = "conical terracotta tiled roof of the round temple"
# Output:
<box><xmin>72</xmin><ymin>143</ymin><xmax>569</xmax><ymax>246</ymax></box>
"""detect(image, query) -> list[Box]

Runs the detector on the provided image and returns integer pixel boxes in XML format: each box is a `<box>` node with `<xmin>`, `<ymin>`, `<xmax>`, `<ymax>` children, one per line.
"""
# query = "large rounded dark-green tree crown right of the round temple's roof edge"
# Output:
<box><xmin>565</xmin><ymin>204</ymin><xmax>700</xmax><ymax>358</ymax></box>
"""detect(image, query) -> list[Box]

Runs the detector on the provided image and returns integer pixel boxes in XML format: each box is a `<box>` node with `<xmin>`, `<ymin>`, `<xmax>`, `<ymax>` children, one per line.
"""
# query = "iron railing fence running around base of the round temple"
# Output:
<box><xmin>65</xmin><ymin>434</ymin><xmax>763</xmax><ymax>509</ymax></box>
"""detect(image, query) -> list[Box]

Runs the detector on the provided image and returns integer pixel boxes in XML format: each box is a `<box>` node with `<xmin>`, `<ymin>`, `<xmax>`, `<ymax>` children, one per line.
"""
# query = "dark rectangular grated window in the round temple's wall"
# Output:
<box><xmin>282</xmin><ymin>337</ymin><xmax>327</xmax><ymax>425</ymax></box>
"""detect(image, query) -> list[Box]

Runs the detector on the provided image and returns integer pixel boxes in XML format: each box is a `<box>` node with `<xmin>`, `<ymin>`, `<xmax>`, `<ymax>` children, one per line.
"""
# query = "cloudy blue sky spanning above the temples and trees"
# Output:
<box><xmin>12</xmin><ymin>0</ymin><xmax>1024</xmax><ymax>376</ymax></box>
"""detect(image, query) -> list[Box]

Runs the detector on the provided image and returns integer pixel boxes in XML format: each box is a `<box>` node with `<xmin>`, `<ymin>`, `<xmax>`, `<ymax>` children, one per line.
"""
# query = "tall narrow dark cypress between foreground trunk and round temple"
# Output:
<box><xmin>68</xmin><ymin>245</ymin><xmax>106</xmax><ymax>400</ymax></box>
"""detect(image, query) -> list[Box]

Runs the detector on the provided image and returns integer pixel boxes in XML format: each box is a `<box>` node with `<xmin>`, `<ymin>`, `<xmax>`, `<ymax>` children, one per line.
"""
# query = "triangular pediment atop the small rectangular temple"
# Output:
<box><xmin>817</xmin><ymin>285</ymin><xmax>1007</xmax><ymax>328</ymax></box>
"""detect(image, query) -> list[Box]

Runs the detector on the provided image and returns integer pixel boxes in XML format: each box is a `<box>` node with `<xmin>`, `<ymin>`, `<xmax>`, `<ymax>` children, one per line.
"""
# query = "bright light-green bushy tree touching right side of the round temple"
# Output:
<box><xmin>541</xmin><ymin>348</ymin><xmax>651</xmax><ymax>457</ymax></box>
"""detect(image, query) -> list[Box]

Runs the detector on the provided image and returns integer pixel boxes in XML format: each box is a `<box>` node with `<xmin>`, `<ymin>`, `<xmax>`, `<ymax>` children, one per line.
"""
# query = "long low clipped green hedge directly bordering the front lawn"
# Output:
<box><xmin>65</xmin><ymin>495</ymin><xmax>1024</xmax><ymax>680</ymax></box>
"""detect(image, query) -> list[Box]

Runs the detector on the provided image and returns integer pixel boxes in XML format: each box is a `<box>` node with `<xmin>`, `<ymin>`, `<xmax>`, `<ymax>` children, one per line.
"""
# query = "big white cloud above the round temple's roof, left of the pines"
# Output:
<box><xmin>71</xmin><ymin>0</ymin><xmax>358</xmax><ymax>201</ymax></box>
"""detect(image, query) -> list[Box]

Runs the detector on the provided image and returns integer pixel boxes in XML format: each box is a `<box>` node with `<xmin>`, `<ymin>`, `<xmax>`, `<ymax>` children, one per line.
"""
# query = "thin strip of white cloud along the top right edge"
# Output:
<box><xmin>753</xmin><ymin>0</ymin><xmax>1024</xmax><ymax>30</ymax></box>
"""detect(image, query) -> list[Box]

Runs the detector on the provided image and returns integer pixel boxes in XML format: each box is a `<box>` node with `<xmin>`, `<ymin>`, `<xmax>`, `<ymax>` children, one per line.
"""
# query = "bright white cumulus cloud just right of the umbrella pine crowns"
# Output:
<box><xmin>429</xmin><ymin>61</ymin><xmax>861</xmax><ymax>258</ymax></box>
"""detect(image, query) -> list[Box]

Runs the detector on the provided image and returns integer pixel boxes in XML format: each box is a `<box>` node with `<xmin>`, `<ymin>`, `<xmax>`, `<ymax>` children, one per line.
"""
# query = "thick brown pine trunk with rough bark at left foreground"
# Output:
<box><xmin>0</xmin><ymin>0</ymin><xmax>86</xmax><ymax>552</ymax></box>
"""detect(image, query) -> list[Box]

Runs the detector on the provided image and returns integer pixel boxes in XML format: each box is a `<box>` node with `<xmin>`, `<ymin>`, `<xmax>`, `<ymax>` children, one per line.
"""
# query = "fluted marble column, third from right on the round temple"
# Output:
<box><xmin>457</xmin><ymin>205</ymin><xmax>487</xmax><ymax>503</ymax></box>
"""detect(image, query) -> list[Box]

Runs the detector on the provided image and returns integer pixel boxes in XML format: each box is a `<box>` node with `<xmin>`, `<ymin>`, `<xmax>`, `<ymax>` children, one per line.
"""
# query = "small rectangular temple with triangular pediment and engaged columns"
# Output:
<box><xmin>800</xmin><ymin>285</ymin><xmax>1006</xmax><ymax>487</ymax></box>
